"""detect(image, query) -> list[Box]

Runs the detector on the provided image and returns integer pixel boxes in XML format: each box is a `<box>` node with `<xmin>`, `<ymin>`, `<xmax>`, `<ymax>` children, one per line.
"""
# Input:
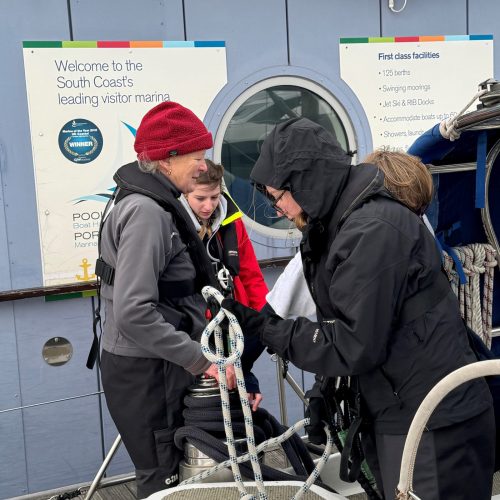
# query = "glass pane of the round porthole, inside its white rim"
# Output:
<box><xmin>221</xmin><ymin>85</ymin><xmax>348</xmax><ymax>229</ymax></box>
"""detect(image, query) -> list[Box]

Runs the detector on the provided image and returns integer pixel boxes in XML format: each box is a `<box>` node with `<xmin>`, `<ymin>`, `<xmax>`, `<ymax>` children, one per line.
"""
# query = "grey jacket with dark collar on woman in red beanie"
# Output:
<box><xmin>100</xmin><ymin>162</ymin><xmax>215</xmax><ymax>374</ymax></box>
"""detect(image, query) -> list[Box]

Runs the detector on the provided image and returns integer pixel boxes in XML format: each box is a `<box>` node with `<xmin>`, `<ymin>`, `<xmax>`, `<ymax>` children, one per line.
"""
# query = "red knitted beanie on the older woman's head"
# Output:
<box><xmin>134</xmin><ymin>101</ymin><xmax>213</xmax><ymax>161</ymax></box>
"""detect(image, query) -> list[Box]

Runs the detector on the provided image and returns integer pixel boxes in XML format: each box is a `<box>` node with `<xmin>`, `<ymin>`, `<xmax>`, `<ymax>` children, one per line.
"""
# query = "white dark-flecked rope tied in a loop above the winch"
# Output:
<box><xmin>181</xmin><ymin>286</ymin><xmax>333</xmax><ymax>500</ymax></box>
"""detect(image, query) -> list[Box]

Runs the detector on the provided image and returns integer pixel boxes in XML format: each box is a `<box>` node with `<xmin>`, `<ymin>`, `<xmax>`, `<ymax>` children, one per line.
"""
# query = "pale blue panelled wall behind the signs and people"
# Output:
<box><xmin>0</xmin><ymin>0</ymin><xmax>500</xmax><ymax>498</ymax></box>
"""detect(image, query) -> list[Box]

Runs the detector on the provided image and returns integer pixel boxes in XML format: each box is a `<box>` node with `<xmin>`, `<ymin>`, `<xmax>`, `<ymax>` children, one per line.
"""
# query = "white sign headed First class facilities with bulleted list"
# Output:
<box><xmin>339</xmin><ymin>35</ymin><xmax>493</xmax><ymax>150</ymax></box>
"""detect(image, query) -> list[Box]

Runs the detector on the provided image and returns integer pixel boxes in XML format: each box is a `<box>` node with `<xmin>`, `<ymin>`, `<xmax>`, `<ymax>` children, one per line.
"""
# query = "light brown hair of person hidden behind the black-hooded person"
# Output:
<box><xmin>364</xmin><ymin>149</ymin><xmax>434</xmax><ymax>215</ymax></box>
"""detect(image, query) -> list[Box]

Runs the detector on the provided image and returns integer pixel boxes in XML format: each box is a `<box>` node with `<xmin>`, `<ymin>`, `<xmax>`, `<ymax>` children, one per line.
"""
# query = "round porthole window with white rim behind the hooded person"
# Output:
<box><xmin>215</xmin><ymin>77</ymin><xmax>355</xmax><ymax>238</ymax></box>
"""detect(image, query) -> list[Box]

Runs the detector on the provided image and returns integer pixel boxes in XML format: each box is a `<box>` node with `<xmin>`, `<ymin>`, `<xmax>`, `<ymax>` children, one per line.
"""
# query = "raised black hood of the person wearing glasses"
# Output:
<box><xmin>250</xmin><ymin>118</ymin><xmax>351</xmax><ymax>219</ymax></box>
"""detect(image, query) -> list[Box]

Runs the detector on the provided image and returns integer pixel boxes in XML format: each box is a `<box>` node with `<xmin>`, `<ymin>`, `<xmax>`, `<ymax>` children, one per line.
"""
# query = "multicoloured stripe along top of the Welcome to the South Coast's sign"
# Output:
<box><xmin>23</xmin><ymin>40</ymin><xmax>226</xmax><ymax>49</ymax></box>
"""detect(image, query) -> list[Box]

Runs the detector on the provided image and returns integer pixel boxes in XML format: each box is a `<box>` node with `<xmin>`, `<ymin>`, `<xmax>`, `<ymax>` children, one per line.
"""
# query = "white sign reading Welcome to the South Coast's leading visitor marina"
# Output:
<box><xmin>23</xmin><ymin>41</ymin><xmax>227</xmax><ymax>286</ymax></box>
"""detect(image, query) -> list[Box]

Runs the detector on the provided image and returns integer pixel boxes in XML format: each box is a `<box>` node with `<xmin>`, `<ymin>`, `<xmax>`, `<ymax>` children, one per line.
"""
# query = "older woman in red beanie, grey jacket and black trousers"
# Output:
<box><xmin>96</xmin><ymin>102</ymin><xmax>235</xmax><ymax>498</ymax></box>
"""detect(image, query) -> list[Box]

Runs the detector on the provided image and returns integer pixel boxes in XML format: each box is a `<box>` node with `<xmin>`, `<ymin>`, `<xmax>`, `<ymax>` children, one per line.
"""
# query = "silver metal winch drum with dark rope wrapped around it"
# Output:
<box><xmin>179</xmin><ymin>378</ymin><xmax>263</xmax><ymax>483</ymax></box>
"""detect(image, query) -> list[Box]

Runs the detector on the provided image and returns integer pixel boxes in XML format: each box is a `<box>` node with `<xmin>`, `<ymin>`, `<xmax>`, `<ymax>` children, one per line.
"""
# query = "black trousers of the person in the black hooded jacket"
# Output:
<box><xmin>363</xmin><ymin>410</ymin><xmax>495</xmax><ymax>500</ymax></box>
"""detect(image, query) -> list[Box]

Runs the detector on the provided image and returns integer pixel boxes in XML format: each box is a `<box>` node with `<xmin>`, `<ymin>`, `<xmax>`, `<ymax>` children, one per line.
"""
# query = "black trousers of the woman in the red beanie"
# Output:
<box><xmin>101</xmin><ymin>351</ymin><xmax>194</xmax><ymax>498</ymax></box>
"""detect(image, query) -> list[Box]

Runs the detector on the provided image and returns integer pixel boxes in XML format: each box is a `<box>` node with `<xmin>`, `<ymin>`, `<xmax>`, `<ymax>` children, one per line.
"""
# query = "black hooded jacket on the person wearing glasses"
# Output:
<box><xmin>251</xmin><ymin>118</ymin><xmax>491</xmax><ymax>434</ymax></box>
